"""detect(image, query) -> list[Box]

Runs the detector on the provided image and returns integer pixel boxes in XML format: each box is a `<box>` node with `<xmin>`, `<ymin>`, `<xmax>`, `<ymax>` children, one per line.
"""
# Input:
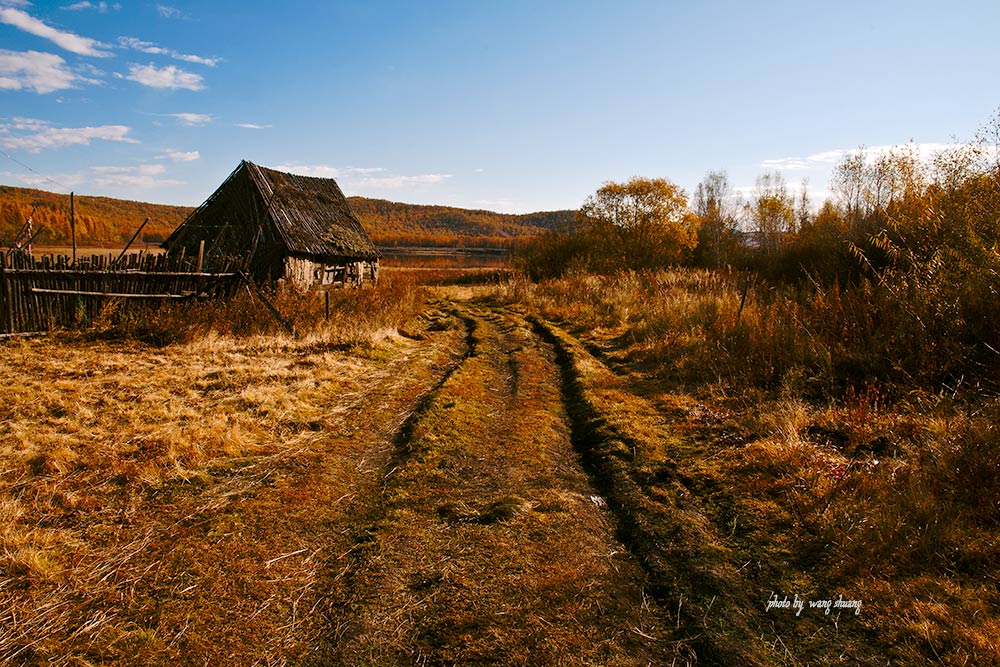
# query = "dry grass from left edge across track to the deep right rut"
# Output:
<box><xmin>0</xmin><ymin>275</ymin><xmax>683</xmax><ymax>665</ymax></box>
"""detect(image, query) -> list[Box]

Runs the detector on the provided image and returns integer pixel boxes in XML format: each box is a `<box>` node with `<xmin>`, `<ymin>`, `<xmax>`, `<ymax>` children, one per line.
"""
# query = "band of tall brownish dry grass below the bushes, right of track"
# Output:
<box><xmin>495</xmin><ymin>269</ymin><xmax>1000</xmax><ymax>399</ymax></box>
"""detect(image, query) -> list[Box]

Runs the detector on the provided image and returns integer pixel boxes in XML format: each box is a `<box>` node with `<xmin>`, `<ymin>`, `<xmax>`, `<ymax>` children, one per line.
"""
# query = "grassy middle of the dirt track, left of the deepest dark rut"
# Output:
<box><xmin>308</xmin><ymin>307</ymin><xmax>678</xmax><ymax>665</ymax></box>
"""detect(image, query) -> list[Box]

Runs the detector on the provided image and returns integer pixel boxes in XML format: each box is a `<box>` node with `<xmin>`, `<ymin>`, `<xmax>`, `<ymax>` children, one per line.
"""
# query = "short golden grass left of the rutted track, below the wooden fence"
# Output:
<box><xmin>0</xmin><ymin>274</ymin><xmax>460</xmax><ymax>665</ymax></box>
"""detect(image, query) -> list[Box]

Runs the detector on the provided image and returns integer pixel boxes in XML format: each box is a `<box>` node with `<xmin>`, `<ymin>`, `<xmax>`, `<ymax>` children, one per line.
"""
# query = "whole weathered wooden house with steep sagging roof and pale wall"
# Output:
<box><xmin>163</xmin><ymin>160</ymin><xmax>379</xmax><ymax>289</ymax></box>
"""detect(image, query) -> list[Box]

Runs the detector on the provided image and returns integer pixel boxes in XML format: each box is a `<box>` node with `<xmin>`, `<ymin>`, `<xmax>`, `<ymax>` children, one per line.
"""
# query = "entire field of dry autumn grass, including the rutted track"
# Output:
<box><xmin>0</xmin><ymin>270</ymin><xmax>1000</xmax><ymax>665</ymax></box>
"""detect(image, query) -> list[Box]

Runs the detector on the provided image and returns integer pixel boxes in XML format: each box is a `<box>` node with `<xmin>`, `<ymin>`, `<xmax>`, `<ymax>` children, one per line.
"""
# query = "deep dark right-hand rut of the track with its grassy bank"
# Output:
<box><xmin>529</xmin><ymin>317</ymin><xmax>767</xmax><ymax>665</ymax></box>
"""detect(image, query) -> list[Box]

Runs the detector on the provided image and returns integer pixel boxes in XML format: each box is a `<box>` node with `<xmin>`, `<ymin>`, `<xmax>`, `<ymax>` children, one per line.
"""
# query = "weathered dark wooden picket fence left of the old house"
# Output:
<box><xmin>0</xmin><ymin>251</ymin><xmax>243</xmax><ymax>335</ymax></box>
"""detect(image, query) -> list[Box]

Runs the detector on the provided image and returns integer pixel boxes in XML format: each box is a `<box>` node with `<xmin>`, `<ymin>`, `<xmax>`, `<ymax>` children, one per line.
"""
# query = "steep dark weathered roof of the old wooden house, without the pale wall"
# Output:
<box><xmin>163</xmin><ymin>160</ymin><xmax>378</xmax><ymax>260</ymax></box>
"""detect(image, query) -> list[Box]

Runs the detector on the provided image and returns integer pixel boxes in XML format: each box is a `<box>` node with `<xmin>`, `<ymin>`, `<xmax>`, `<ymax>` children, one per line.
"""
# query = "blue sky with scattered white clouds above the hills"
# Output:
<box><xmin>0</xmin><ymin>0</ymin><xmax>1000</xmax><ymax>212</ymax></box>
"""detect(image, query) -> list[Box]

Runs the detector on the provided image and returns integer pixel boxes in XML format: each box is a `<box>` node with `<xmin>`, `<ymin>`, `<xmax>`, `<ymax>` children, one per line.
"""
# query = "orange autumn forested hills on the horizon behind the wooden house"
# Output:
<box><xmin>0</xmin><ymin>185</ymin><xmax>574</xmax><ymax>247</ymax></box>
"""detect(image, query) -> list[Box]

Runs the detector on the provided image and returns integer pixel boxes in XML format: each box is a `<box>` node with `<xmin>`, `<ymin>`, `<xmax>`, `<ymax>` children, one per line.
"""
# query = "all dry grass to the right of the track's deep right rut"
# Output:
<box><xmin>494</xmin><ymin>271</ymin><xmax>1000</xmax><ymax>665</ymax></box>
